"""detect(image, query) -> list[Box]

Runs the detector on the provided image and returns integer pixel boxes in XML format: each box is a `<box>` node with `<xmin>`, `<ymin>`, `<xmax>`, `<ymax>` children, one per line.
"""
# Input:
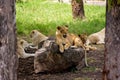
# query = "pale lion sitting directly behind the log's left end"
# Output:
<box><xmin>30</xmin><ymin>30</ymin><xmax>48</xmax><ymax>48</ymax></box>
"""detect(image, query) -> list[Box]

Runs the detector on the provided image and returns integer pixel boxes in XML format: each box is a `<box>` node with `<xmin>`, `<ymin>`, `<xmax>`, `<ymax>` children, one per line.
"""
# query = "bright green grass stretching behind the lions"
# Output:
<box><xmin>16</xmin><ymin>0</ymin><xmax>105</xmax><ymax>36</ymax></box>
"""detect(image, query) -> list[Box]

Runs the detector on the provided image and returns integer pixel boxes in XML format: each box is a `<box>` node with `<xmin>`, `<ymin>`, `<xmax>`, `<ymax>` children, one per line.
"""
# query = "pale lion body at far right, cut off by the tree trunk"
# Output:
<box><xmin>86</xmin><ymin>28</ymin><xmax>105</xmax><ymax>45</ymax></box>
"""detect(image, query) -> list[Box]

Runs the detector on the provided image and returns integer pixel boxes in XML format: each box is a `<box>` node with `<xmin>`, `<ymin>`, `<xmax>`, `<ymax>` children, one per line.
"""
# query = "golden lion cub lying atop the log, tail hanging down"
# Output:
<box><xmin>56</xmin><ymin>26</ymin><xmax>88</xmax><ymax>66</ymax></box>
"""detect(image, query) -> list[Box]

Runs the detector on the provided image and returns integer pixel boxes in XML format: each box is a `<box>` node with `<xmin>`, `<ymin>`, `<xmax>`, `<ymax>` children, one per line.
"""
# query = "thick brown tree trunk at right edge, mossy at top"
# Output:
<box><xmin>103</xmin><ymin>0</ymin><xmax>120</xmax><ymax>80</ymax></box>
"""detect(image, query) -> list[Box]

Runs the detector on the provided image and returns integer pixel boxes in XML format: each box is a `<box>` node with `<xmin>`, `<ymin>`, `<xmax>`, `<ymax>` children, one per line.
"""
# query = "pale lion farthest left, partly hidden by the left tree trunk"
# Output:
<box><xmin>16</xmin><ymin>39</ymin><xmax>35</xmax><ymax>58</ymax></box>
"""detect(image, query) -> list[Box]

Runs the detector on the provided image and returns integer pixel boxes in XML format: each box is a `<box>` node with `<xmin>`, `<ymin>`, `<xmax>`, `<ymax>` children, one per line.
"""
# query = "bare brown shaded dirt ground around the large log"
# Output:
<box><xmin>18</xmin><ymin>45</ymin><xmax>104</xmax><ymax>80</ymax></box>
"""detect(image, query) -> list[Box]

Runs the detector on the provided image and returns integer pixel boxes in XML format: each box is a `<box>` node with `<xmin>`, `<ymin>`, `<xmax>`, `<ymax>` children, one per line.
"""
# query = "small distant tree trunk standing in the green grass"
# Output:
<box><xmin>71</xmin><ymin>0</ymin><xmax>85</xmax><ymax>19</ymax></box>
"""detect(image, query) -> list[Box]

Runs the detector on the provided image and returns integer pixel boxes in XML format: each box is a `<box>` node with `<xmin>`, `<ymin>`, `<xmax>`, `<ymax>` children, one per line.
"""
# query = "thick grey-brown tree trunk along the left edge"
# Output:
<box><xmin>0</xmin><ymin>0</ymin><xmax>17</xmax><ymax>80</ymax></box>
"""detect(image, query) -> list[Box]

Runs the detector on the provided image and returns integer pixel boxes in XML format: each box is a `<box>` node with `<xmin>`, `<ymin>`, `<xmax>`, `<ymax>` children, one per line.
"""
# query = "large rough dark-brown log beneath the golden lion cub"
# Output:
<box><xmin>34</xmin><ymin>40</ymin><xmax>84</xmax><ymax>73</ymax></box>
